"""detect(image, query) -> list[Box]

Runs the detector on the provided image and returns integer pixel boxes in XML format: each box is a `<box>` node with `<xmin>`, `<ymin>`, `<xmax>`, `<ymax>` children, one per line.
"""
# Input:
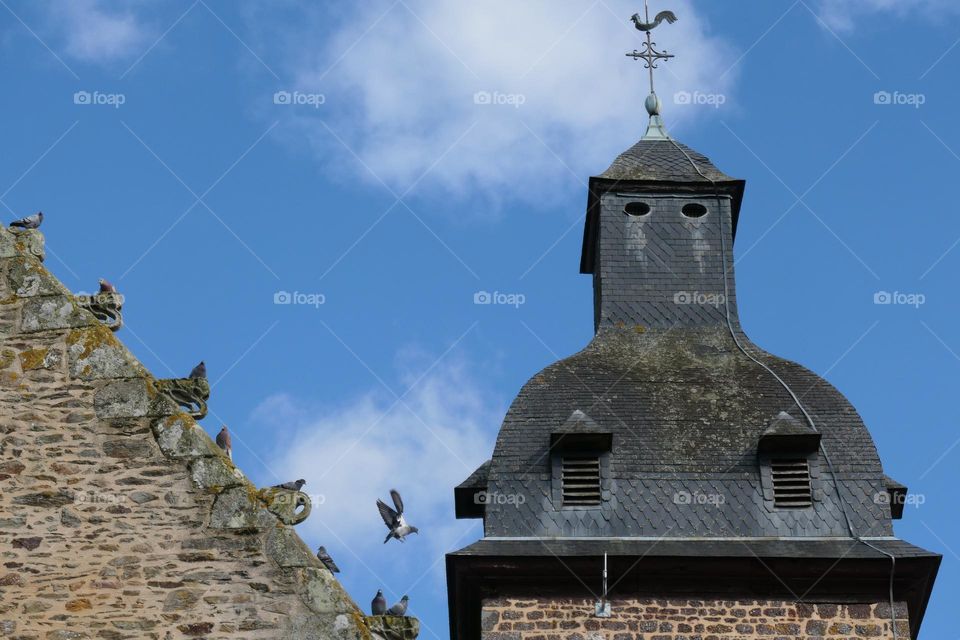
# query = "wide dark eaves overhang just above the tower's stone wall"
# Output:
<box><xmin>446</xmin><ymin>538</ymin><xmax>942</xmax><ymax>640</ymax></box>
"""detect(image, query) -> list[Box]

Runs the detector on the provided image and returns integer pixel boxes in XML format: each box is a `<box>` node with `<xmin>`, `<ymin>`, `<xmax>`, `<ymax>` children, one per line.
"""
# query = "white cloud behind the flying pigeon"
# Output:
<box><xmin>254</xmin><ymin>354</ymin><xmax>503</xmax><ymax>592</ymax></box>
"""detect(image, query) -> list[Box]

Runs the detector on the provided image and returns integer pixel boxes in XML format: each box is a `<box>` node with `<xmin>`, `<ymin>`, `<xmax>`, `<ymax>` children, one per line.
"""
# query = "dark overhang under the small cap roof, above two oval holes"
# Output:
<box><xmin>580</xmin><ymin>176</ymin><xmax>747</xmax><ymax>273</ymax></box>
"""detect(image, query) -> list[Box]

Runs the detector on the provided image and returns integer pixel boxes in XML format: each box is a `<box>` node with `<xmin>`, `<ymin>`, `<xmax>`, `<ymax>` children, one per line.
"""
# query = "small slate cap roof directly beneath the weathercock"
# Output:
<box><xmin>598</xmin><ymin>140</ymin><xmax>734</xmax><ymax>183</ymax></box>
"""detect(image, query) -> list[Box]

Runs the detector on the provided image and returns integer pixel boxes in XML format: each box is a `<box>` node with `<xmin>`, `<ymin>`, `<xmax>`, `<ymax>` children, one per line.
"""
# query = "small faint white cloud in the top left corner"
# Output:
<box><xmin>48</xmin><ymin>0</ymin><xmax>149</xmax><ymax>63</ymax></box>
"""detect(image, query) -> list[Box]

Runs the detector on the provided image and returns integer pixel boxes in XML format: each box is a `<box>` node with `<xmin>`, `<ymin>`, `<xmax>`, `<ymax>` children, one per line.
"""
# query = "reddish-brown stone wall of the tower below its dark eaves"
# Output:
<box><xmin>482</xmin><ymin>598</ymin><xmax>910</xmax><ymax>640</ymax></box>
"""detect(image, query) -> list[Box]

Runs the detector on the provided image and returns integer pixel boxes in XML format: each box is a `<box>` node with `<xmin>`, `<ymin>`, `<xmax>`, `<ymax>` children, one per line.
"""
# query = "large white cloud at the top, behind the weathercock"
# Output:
<box><xmin>270</xmin><ymin>0</ymin><xmax>736</xmax><ymax>199</ymax></box>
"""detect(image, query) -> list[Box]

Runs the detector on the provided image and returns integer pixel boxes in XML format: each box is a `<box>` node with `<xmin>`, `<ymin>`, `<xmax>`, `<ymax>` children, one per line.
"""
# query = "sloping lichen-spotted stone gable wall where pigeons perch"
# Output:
<box><xmin>0</xmin><ymin>229</ymin><xmax>371</xmax><ymax>640</ymax></box>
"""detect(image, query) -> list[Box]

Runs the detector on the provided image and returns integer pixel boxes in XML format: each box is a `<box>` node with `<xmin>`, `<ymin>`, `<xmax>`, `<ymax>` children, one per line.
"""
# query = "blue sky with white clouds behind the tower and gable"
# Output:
<box><xmin>0</xmin><ymin>0</ymin><xmax>960</xmax><ymax>640</ymax></box>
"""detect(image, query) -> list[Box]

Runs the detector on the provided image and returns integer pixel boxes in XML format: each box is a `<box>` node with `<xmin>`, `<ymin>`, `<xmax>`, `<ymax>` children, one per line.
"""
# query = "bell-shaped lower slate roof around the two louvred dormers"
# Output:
<box><xmin>484</xmin><ymin>326</ymin><xmax>892</xmax><ymax>538</ymax></box>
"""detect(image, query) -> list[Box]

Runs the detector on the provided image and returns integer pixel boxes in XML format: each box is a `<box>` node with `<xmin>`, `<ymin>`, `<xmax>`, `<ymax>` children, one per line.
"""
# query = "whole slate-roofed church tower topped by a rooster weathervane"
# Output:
<box><xmin>447</xmin><ymin>6</ymin><xmax>941</xmax><ymax>640</ymax></box>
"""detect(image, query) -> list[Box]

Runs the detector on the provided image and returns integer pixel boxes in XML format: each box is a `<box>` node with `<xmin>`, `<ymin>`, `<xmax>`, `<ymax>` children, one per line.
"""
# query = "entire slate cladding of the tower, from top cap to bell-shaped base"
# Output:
<box><xmin>460</xmin><ymin>132</ymin><xmax>908</xmax><ymax>539</ymax></box>
